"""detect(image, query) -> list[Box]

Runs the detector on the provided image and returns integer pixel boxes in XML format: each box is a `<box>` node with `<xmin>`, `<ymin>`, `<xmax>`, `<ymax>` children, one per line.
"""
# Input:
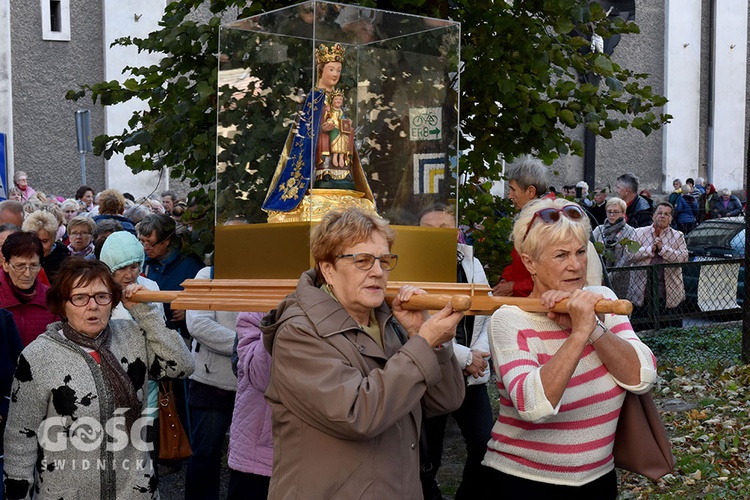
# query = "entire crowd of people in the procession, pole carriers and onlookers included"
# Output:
<box><xmin>0</xmin><ymin>158</ymin><xmax>742</xmax><ymax>500</ymax></box>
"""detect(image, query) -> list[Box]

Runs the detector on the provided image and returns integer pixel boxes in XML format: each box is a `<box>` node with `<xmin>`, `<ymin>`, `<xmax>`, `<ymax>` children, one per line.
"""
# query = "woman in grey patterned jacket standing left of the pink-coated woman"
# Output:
<box><xmin>592</xmin><ymin>197</ymin><xmax>635</xmax><ymax>297</ymax></box>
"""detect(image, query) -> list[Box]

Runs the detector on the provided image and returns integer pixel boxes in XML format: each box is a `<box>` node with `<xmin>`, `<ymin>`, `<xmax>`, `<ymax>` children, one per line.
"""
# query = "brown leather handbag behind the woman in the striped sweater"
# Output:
<box><xmin>612</xmin><ymin>392</ymin><xmax>676</xmax><ymax>481</ymax></box>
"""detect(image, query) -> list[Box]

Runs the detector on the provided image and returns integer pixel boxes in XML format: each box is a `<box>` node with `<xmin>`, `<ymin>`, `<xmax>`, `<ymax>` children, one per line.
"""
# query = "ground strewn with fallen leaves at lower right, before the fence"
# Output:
<box><xmin>438</xmin><ymin>324</ymin><xmax>750</xmax><ymax>500</ymax></box>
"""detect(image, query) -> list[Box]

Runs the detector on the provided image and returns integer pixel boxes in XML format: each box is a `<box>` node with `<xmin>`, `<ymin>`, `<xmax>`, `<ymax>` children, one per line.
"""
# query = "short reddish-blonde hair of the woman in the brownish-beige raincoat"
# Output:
<box><xmin>310</xmin><ymin>208</ymin><xmax>396</xmax><ymax>281</ymax></box>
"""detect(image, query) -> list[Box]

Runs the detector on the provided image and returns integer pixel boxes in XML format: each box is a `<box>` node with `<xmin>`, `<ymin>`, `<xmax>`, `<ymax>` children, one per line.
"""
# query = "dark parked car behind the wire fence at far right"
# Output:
<box><xmin>683</xmin><ymin>217</ymin><xmax>745</xmax><ymax>311</ymax></box>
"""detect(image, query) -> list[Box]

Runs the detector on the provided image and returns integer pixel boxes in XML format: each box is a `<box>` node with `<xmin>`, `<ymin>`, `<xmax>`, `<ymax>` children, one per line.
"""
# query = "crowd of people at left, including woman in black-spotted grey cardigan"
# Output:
<box><xmin>0</xmin><ymin>177</ymin><xmax>203</xmax><ymax>499</ymax></box>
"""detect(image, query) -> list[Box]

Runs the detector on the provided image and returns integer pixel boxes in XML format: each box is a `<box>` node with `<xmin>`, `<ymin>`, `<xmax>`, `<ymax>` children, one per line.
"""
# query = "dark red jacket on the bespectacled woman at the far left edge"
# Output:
<box><xmin>0</xmin><ymin>271</ymin><xmax>60</xmax><ymax>347</ymax></box>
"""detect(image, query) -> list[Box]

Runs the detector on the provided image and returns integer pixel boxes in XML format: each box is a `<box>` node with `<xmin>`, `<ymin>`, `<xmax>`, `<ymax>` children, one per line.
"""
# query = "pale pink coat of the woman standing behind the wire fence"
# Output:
<box><xmin>628</xmin><ymin>225</ymin><xmax>688</xmax><ymax>308</ymax></box>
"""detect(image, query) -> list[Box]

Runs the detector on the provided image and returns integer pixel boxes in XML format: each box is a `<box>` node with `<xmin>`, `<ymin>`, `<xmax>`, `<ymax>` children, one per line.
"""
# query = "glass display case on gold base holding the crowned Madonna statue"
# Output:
<box><xmin>216</xmin><ymin>1</ymin><xmax>460</xmax><ymax>281</ymax></box>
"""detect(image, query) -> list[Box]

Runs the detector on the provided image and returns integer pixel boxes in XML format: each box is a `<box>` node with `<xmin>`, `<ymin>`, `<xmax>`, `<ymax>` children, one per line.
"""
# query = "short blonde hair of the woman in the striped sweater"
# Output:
<box><xmin>513</xmin><ymin>198</ymin><xmax>591</xmax><ymax>260</ymax></box>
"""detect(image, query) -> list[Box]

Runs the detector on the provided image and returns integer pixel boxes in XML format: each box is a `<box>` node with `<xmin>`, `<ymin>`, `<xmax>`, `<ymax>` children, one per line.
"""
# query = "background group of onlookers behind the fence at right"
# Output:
<box><xmin>582</xmin><ymin>173</ymin><xmax>745</xmax><ymax>329</ymax></box>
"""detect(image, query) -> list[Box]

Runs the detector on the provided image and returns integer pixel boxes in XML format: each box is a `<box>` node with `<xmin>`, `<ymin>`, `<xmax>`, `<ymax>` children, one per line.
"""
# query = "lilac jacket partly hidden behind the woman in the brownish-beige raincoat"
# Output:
<box><xmin>228</xmin><ymin>312</ymin><xmax>273</xmax><ymax>476</ymax></box>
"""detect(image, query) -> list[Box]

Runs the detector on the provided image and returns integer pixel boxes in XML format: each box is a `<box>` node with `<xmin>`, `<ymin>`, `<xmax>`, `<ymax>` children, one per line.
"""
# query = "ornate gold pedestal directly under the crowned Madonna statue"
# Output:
<box><xmin>268</xmin><ymin>189</ymin><xmax>376</xmax><ymax>224</ymax></box>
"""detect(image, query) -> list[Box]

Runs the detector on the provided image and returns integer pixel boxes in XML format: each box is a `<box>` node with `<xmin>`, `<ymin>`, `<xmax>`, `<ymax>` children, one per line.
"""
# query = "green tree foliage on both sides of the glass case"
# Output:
<box><xmin>67</xmin><ymin>0</ymin><xmax>670</xmax><ymax>280</ymax></box>
